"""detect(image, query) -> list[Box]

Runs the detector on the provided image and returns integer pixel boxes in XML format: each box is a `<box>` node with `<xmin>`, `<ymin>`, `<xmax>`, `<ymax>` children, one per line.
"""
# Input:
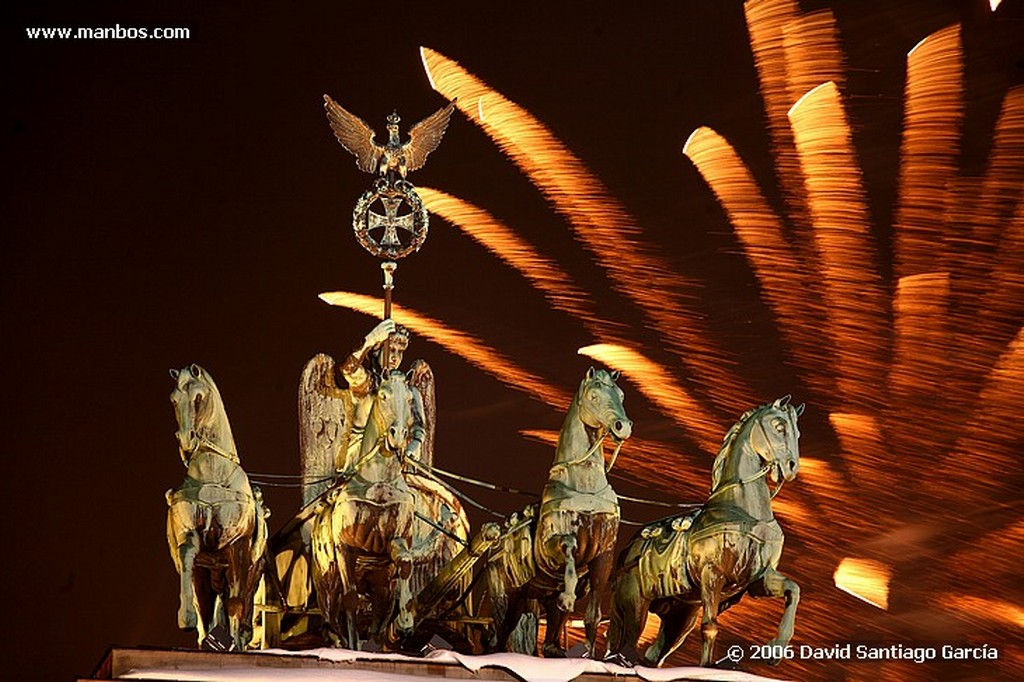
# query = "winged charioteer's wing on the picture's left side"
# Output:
<box><xmin>299</xmin><ymin>353</ymin><xmax>352</xmax><ymax>505</ymax></box>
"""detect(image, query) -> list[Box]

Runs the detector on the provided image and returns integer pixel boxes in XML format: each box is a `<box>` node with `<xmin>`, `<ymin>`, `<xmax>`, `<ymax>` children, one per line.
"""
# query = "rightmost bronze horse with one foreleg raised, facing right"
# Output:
<box><xmin>607</xmin><ymin>396</ymin><xmax>804</xmax><ymax>666</ymax></box>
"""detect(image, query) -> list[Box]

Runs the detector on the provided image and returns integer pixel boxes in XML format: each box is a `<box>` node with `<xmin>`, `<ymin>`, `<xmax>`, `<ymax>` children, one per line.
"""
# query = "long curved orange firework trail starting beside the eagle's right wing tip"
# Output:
<box><xmin>421</xmin><ymin>48</ymin><xmax>753</xmax><ymax>414</ymax></box>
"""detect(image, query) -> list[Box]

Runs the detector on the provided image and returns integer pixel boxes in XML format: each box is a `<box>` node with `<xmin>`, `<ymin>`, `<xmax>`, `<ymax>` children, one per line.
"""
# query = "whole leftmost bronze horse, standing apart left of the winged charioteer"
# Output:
<box><xmin>166</xmin><ymin>365</ymin><xmax>269</xmax><ymax>650</ymax></box>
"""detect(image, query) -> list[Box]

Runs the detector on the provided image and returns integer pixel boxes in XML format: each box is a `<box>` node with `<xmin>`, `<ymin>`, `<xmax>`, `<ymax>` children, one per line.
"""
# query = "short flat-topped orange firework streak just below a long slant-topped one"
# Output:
<box><xmin>887</xmin><ymin>272</ymin><xmax>954</xmax><ymax>453</ymax></box>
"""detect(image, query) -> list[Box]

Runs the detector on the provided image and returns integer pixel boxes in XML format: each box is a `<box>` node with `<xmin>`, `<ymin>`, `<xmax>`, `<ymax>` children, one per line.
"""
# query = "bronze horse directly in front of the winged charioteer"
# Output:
<box><xmin>311</xmin><ymin>370</ymin><xmax>423</xmax><ymax>649</ymax></box>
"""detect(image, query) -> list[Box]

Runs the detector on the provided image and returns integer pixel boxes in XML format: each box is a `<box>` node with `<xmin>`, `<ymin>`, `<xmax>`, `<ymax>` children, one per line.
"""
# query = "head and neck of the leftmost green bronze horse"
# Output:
<box><xmin>170</xmin><ymin>363</ymin><xmax>238</xmax><ymax>464</ymax></box>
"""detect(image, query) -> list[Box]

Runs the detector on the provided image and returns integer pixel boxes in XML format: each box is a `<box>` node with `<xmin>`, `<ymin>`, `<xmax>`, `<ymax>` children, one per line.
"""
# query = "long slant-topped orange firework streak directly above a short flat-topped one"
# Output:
<box><xmin>893</xmin><ymin>25</ymin><xmax>964</xmax><ymax>276</ymax></box>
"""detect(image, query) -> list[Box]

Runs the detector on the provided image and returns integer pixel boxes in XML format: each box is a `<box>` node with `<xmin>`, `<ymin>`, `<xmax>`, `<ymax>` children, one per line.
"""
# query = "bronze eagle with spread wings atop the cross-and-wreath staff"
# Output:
<box><xmin>324</xmin><ymin>95</ymin><xmax>455</xmax><ymax>178</ymax></box>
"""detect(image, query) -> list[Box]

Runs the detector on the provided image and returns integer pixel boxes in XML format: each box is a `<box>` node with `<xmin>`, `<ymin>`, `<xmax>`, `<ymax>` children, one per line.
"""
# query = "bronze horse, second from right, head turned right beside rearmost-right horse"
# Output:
<box><xmin>486</xmin><ymin>368</ymin><xmax>633</xmax><ymax>656</ymax></box>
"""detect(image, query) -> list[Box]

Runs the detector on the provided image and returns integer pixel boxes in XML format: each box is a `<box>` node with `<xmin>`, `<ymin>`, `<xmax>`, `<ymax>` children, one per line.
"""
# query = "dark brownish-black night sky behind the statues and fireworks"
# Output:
<box><xmin>0</xmin><ymin>0</ymin><xmax>1024</xmax><ymax>679</ymax></box>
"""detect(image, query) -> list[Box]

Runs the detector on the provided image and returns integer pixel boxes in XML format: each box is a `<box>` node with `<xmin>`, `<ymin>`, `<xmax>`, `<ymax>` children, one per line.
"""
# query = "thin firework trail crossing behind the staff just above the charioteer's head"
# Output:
<box><xmin>319</xmin><ymin>291</ymin><xmax>571</xmax><ymax>410</ymax></box>
